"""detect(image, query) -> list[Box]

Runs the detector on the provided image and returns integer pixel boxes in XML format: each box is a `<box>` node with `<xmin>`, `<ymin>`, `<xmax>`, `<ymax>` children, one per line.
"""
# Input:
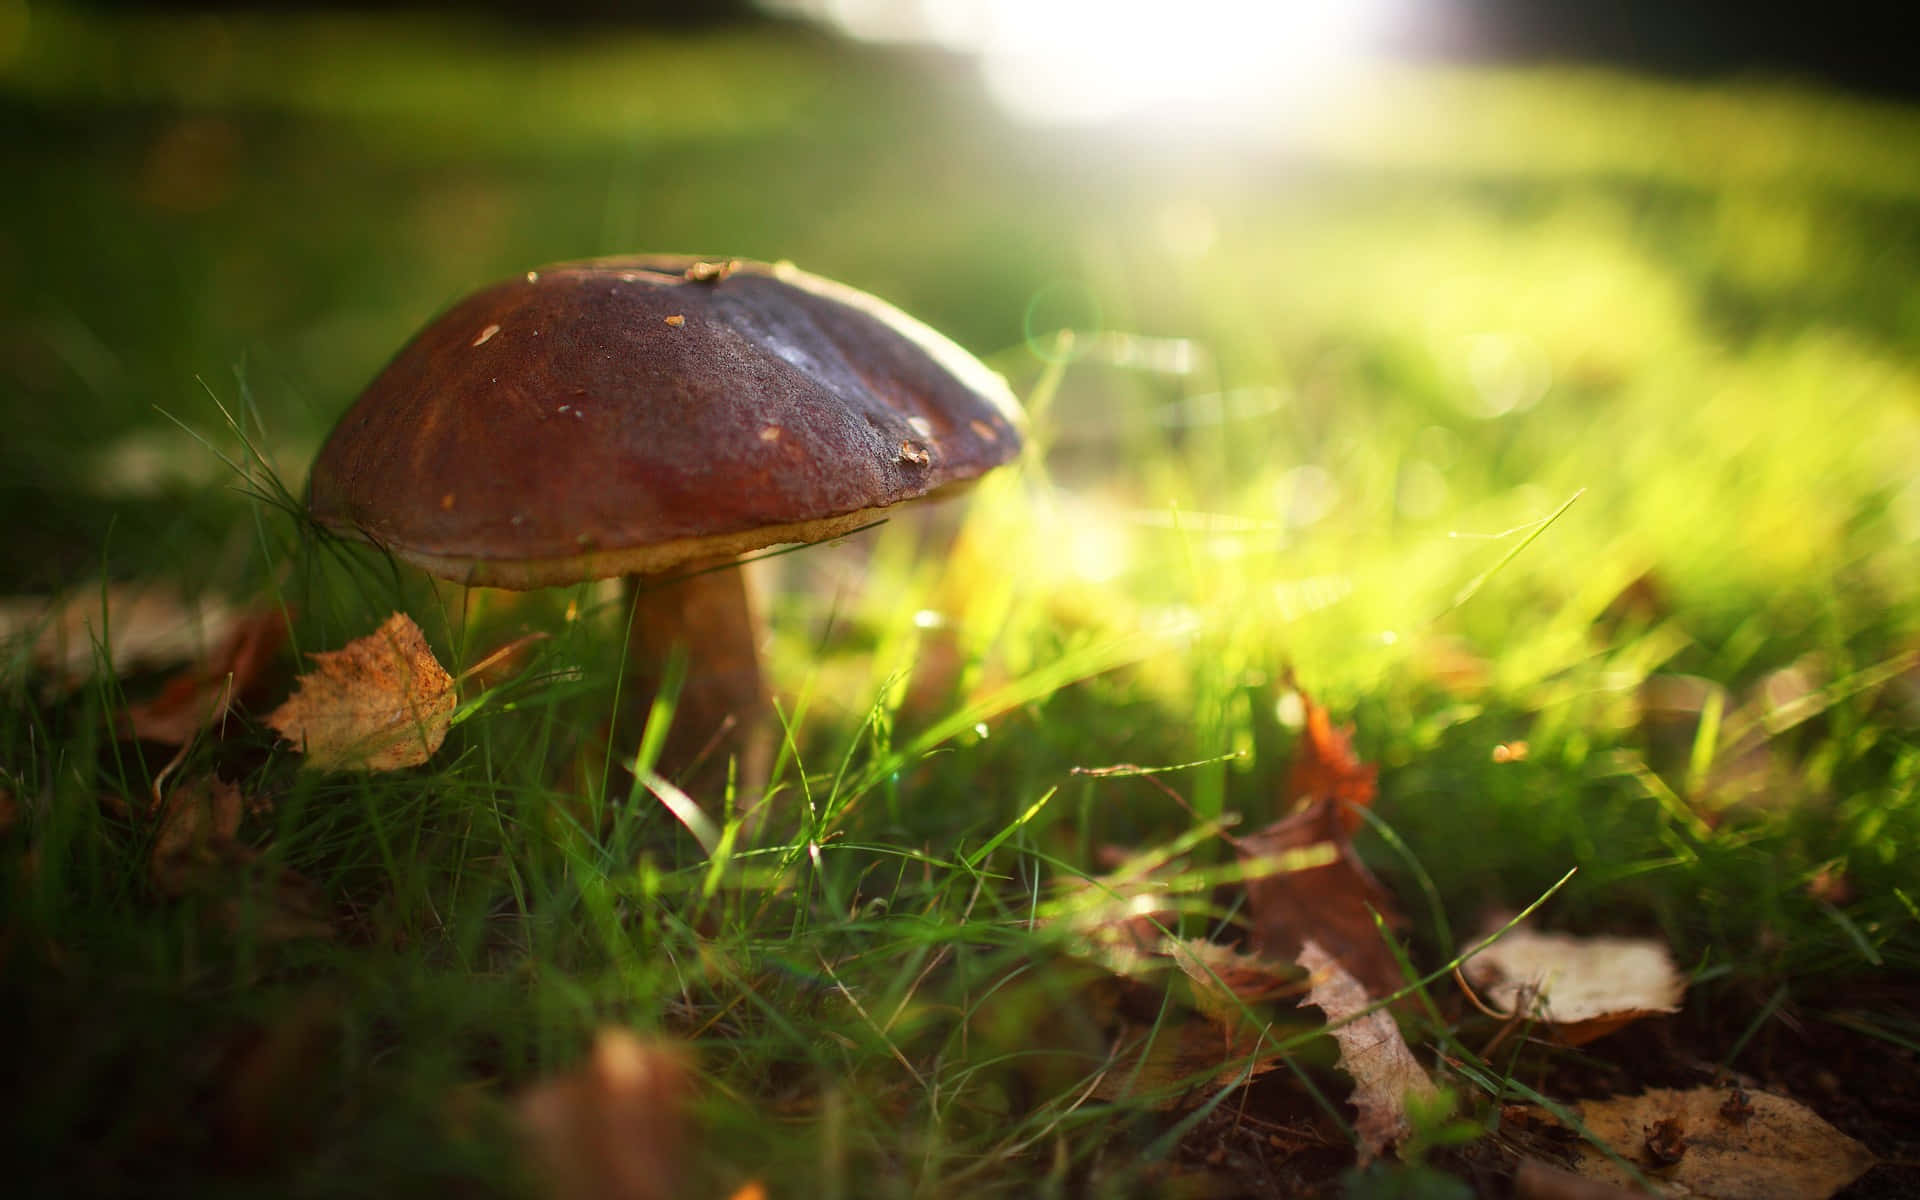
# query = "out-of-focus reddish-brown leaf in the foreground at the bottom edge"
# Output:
<box><xmin>518</xmin><ymin>1029</ymin><xmax>693</xmax><ymax>1200</ymax></box>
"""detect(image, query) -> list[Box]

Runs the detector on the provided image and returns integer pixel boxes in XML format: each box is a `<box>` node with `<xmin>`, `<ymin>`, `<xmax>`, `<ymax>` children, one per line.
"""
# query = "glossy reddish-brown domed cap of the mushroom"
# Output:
<box><xmin>307</xmin><ymin>255</ymin><xmax>1020</xmax><ymax>588</ymax></box>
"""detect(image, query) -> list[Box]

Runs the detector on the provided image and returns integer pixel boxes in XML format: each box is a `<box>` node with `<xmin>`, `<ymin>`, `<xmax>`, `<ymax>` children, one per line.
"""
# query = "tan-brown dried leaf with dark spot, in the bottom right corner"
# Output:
<box><xmin>1574</xmin><ymin>1087</ymin><xmax>1874</xmax><ymax>1200</ymax></box>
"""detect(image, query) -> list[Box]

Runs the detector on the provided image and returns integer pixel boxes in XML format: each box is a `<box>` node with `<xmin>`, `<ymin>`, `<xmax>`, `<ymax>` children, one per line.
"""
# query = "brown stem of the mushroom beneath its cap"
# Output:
<box><xmin>626</xmin><ymin>559</ymin><xmax>774</xmax><ymax>808</ymax></box>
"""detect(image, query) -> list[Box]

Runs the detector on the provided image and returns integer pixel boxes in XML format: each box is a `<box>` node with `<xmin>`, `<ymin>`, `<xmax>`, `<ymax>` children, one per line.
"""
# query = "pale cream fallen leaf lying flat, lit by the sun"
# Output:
<box><xmin>1461</xmin><ymin>925</ymin><xmax>1686</xmax><ymax>1046</ymax></box>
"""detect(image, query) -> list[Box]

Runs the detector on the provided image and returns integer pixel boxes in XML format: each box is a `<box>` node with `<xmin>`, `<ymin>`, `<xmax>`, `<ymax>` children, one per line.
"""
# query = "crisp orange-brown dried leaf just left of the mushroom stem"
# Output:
<box><xmin>267</xmin><ymin>612</ymin><xmax>455</xmax><ymax>770</ymax></box>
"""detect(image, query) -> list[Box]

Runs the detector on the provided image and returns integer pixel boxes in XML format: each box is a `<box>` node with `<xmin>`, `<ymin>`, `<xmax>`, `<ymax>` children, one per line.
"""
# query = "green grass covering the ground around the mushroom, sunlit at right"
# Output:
<box><xmin>0</xmin><ymin>4</ymin><xmax>1920</xmax><ymax>1196</ymax></box>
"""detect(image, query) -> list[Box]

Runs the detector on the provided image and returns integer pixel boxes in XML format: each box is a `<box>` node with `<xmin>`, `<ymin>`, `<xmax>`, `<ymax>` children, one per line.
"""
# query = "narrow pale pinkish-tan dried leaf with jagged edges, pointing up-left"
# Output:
<box><xmin>1298</xmin><ymin>939</ymin><xmax>1436</xmax><ymax>1165</ymax></box>
